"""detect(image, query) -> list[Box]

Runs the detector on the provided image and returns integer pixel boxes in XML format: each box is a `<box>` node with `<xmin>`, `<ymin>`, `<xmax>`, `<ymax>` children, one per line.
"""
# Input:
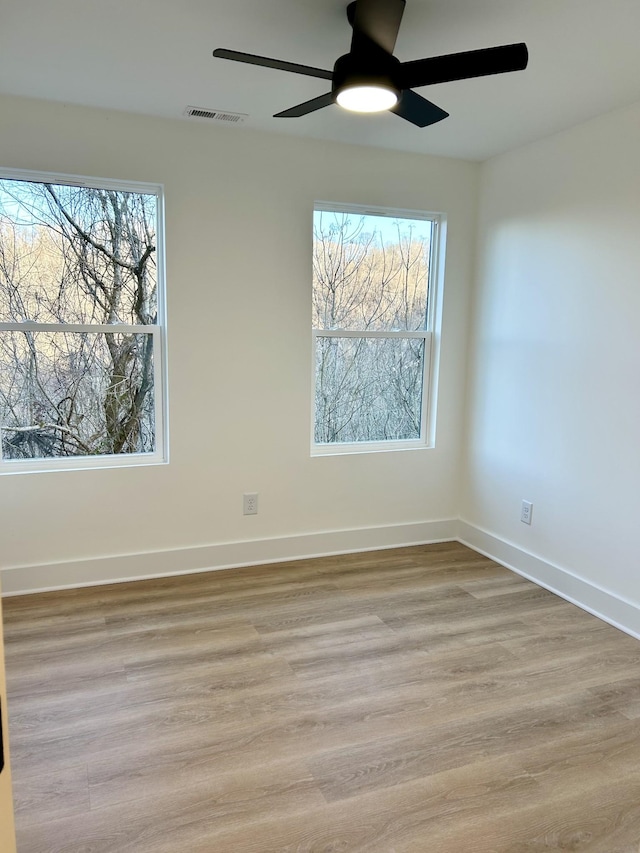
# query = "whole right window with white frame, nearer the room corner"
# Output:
<box><xmin>312</xmin><ymin>205</ymin><xmax>439</xmax><ymax>454</ymax></box>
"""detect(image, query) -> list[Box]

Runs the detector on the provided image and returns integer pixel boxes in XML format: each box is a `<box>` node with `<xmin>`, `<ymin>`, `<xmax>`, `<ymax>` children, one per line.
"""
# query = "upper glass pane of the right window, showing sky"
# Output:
<box><xmin>313</xmin><ymin>210</ymin><xmax>433</xmax><ymax>331</ymax></box>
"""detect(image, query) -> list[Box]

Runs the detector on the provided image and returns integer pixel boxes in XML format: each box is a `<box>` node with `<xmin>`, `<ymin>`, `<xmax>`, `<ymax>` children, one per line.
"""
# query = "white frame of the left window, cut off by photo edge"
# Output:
<box><xmin>0</xmin><ymin>167</ymin><xmax>169</xmax><ymax>476</ymax></box>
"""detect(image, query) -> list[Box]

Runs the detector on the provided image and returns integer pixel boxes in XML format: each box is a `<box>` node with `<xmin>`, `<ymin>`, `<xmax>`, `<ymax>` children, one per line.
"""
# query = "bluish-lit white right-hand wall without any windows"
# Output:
<box><xmin>461</xmin><ymin>98</ymin><xmax>640</xmax><ymax>631</ymax></box>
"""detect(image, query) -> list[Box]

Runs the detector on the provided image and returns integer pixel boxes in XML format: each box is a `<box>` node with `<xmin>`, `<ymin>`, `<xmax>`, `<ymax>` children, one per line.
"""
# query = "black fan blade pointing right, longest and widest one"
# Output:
<box><xmin>399</xmin><ymin>42</ymin><xmax>529</xmax><ymax>89</ymax></box>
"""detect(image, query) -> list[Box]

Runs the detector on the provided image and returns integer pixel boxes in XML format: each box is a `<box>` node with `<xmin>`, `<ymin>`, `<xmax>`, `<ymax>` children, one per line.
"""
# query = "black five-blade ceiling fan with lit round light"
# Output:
<box><xmin>213</xmin><ymin>0</ymin><xmax>529</xmax><ymax>127</ymax></box>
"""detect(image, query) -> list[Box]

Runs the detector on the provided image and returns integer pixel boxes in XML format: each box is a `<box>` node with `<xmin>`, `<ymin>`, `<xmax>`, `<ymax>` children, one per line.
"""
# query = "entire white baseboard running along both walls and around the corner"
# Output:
<box><xmin>6</xmin><ymin>519</ymin><xmax>640</xmax><ymax>639</ymax></box>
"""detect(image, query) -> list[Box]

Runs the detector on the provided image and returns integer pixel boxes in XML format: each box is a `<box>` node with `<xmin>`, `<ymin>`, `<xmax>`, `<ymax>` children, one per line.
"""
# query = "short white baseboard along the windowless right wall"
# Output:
<box><xmin>457</xmin><ymin>521</ymin><xmax>640</xmax><ymax>639</ymax></box>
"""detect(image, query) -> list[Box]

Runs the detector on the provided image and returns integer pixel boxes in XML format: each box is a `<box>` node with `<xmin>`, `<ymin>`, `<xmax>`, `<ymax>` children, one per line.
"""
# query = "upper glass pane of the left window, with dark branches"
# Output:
<box><xmin>0</xmin><ymin>179</ymin><xmax>157</xmax><ymax>325</ymax></box>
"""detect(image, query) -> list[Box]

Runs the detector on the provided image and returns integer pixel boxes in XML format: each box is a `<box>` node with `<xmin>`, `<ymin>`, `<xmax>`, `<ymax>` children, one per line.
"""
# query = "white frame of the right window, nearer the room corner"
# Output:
<box><xmin>311</xmin><ymin>201</ymin><xmax>446</xmax><ymax>457</ymax></box>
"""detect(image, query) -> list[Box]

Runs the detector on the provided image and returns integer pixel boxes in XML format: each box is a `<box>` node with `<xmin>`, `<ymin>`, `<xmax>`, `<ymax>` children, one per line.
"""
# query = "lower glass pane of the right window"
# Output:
<box><xmin>315</xmin><ymin>336</ymin><xmax>425</xmax><ymax>443</ymax></box>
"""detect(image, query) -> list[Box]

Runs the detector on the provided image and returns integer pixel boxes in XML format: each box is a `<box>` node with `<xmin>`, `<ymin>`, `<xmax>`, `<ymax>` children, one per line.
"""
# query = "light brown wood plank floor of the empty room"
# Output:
<box><xmin>4</xmin><ymin>543</ymin><xmax>640</xmax><ymax>853</ymax></box>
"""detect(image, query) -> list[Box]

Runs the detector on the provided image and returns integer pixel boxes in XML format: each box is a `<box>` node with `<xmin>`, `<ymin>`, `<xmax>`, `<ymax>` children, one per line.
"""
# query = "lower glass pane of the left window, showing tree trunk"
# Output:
<box><xmin>0</xmin><ymin>331</ymin><xmax>155</xmax><ymax>459</ymax></box>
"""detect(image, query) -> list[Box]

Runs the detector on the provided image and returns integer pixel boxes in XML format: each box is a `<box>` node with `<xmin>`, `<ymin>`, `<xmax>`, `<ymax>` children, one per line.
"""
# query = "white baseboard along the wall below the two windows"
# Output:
<box><xmin>1</xmin><ymin>519</ymin><xmax>458</xmax><ymax>596</ymax></box>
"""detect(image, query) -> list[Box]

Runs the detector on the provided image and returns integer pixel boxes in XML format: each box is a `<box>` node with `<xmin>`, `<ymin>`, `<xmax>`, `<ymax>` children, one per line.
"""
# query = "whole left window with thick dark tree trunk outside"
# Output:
<box><xmin>0</xmin><ymin>171</ymin><xmax>166</xmax><ymax>473</ymax></box>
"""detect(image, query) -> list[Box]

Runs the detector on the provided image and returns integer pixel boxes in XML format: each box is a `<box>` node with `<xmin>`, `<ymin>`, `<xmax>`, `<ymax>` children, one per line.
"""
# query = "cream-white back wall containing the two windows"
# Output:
<box><xmin>0</xmin><ymin>91</ymin><xmax>479</xmax><ymax>592</ymax></box>
